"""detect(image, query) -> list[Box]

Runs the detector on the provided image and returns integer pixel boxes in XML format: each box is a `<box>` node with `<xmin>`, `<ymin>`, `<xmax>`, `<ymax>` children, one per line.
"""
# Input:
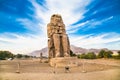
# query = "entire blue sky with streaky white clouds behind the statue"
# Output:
<box><xmin>0</xmin><ymin>0</ymin><xmax>120</xmax><ymax>54</ymax></box>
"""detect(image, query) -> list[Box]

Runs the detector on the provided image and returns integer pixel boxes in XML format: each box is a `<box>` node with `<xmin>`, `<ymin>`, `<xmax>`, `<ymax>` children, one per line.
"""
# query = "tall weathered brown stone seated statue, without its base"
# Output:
<box><xmin>47</xmin><ymin>14</ymin><xmax>70</xmax><ymax>58</ymax></box>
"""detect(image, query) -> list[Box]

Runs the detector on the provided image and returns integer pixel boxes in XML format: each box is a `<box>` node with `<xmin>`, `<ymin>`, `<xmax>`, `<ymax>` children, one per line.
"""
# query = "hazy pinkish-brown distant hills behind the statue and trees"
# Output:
<box><xmin>29</xmin><ymin>45</ymin><xmax>118</xmax><ymax>57</ymax></box>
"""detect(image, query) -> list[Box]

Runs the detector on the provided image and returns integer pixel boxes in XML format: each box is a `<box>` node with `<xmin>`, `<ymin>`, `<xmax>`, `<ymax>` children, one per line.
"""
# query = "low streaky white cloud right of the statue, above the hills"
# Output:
<box><xmin>70</xmin><ymin>33</ymin><xmax>120</xmax><ymax>49</ymax></box>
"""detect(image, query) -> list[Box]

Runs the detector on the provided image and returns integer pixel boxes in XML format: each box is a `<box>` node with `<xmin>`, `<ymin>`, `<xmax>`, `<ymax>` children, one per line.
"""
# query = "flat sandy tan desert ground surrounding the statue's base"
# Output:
<box><xmin>0</xmin><ymin>59</ymin><xmax>120</xmax><ymax>80</ymax></box>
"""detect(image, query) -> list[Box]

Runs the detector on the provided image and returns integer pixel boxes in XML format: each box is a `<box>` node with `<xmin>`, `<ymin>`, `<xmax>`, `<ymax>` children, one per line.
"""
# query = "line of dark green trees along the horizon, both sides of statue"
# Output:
<box><xmin>0</xmin><ymin>50</ymin><xmax>120</xmax><ymax>60</ymax></box>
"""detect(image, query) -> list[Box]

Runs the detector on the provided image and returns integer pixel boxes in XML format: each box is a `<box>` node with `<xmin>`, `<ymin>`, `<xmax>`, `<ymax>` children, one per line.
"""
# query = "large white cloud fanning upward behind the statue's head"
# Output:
<box><xmin>30</xmin><ymin>0</ymin><xmax>91</xmax><ymax>33</ymax></box>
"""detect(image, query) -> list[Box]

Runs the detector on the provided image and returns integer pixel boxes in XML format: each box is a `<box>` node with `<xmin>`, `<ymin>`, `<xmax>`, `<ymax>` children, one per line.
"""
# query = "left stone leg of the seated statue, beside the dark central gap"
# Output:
<box><xmin>53</xmin><ymin>34</ymin><xmax>60</xmax><ymax>57</ymax></box>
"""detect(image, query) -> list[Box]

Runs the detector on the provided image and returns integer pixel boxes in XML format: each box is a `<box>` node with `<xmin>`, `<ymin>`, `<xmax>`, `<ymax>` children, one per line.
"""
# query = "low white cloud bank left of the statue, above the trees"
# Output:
<box><xmin>0</xmin><ymin>34</ymin><xmax>47</xmax><ymax>54</ymax></box>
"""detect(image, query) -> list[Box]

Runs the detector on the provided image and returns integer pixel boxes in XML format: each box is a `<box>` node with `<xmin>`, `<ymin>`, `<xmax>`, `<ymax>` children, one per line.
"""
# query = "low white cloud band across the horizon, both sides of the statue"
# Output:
<box><xmin>0</xmin><ymin>33</ymin><xmax>120</xmax><ymax>54</ymax></box>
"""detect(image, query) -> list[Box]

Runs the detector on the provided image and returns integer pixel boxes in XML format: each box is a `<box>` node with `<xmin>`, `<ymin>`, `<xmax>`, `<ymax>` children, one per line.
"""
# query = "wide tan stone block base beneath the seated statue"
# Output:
<box><xmin>49</xmin><ymin>57</ymin><xmax>78</xmax><ymax>67</ymax></box>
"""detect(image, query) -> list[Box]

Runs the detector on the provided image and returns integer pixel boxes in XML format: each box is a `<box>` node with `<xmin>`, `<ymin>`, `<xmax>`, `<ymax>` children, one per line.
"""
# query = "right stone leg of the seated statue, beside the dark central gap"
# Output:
<box><xmin>62</xmin><ymin>34</ymin><xmax>70</xmax><ymax>57</ymax></box>
